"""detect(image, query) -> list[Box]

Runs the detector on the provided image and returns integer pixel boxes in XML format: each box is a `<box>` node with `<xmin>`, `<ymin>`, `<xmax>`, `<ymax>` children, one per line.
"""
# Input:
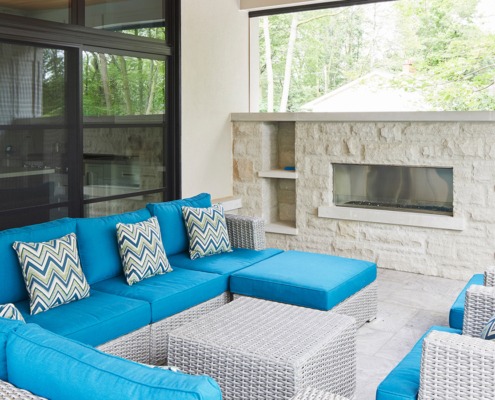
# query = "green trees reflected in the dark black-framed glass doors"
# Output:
<box><xmin>43</xmin><ymin>28</ymin><xmax>166</xmax><ymax>116</ymax></box>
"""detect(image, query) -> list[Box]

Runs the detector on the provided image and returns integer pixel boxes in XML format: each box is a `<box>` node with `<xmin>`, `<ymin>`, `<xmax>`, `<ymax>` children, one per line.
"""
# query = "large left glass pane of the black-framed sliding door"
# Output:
<box><xmin>0</xmin><ymin>43</ymin><xmax>68</xmax><ymax>216</ymax></box>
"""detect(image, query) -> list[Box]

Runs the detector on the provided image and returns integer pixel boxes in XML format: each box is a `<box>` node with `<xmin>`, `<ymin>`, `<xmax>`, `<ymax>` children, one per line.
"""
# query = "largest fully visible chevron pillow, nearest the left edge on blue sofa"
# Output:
<box><xmin>13</xmin><ymin>233</ymin><xmax>89</xmax><ymax>315</ymax></box>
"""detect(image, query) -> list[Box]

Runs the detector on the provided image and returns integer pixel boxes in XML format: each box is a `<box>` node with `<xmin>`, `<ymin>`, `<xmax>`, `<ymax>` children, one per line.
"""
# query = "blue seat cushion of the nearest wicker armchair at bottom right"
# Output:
<box><xmin>376</xmin><ymin>326</ymin><xmax>461</xmax><ymax>400</ymax></box>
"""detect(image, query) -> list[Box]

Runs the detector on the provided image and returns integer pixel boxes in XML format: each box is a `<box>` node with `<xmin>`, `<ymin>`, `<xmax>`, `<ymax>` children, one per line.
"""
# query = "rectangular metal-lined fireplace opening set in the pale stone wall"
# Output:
<box><xmin>333</xmin><ymin>164</ymin><xmax>454</xmax><ymax>216</ymax></box>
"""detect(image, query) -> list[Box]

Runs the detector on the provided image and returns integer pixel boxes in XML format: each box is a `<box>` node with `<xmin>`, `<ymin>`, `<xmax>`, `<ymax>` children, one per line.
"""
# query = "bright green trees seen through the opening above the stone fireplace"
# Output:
<box><xmin>260</xmin><ymin>0</ymin><xmax>495</xmax><ymax>111</ymax></box>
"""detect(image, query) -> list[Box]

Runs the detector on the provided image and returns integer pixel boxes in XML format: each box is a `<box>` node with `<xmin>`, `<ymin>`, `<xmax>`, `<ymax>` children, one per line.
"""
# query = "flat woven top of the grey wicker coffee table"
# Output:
<box><xmin>170</xmin><ymin>297</ymin><xmax>355</xmax><ymax>362</ymax></box>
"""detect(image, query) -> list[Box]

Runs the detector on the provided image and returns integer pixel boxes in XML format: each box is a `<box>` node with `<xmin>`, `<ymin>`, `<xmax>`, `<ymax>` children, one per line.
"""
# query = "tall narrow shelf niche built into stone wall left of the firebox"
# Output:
<box><xmin>258</xmin><ymin>122</ymin><xmax>297</xmax><ymax>235</ymax></box>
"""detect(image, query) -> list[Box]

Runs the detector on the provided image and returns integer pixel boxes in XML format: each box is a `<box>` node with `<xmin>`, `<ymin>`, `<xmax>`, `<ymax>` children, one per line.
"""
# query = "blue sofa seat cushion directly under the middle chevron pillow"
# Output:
<box><xmin>93</xmin><ymin>267</ymin><xmax>228</xmax><ymax>322</ymax></box>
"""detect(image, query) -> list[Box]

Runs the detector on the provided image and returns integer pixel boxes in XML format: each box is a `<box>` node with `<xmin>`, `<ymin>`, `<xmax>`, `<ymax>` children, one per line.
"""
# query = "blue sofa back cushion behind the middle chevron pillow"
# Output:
<box><xmin>76</xmin><ymin>208</ymin><xmax>151</xmax><ymax>285</ymax></box>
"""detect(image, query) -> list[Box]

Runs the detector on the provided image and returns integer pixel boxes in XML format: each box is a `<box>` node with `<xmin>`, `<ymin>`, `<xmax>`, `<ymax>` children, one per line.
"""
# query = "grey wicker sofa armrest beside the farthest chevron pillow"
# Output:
<box><xmin>225</xmin><ymin>214</ymin><xmax>266</xmax><ymax>250</ymax></box>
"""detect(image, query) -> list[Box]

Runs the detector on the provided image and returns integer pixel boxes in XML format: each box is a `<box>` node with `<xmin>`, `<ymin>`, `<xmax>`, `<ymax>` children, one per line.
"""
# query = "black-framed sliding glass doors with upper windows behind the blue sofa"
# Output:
<box><xmin>0</xmin><ymin>0</ymin><xmax>180</xmax><ymax>229</ymax></box>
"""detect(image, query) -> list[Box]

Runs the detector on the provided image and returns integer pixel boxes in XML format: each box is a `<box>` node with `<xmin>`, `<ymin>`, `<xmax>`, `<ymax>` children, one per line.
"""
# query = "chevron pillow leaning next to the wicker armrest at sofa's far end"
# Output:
<box><xmin>182</xmin><ymin>204</ymin><xmax>232</xmax><ymax>260</ymax></box>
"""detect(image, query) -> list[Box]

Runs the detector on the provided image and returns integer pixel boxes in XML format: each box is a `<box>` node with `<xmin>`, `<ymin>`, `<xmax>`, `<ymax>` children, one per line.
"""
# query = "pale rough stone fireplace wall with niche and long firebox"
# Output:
<box><xmin>232</xmin><ymin>112</ymin><xmax>495</xmax><ymax>279</ymax></box>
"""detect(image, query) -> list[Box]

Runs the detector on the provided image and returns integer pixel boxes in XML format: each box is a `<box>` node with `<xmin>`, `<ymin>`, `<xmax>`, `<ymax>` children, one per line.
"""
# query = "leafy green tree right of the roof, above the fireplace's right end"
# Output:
<box><xmin>396</xmin><ymin>0</ymin><xmax>495</xmax><ymax>111</ymax></box>
